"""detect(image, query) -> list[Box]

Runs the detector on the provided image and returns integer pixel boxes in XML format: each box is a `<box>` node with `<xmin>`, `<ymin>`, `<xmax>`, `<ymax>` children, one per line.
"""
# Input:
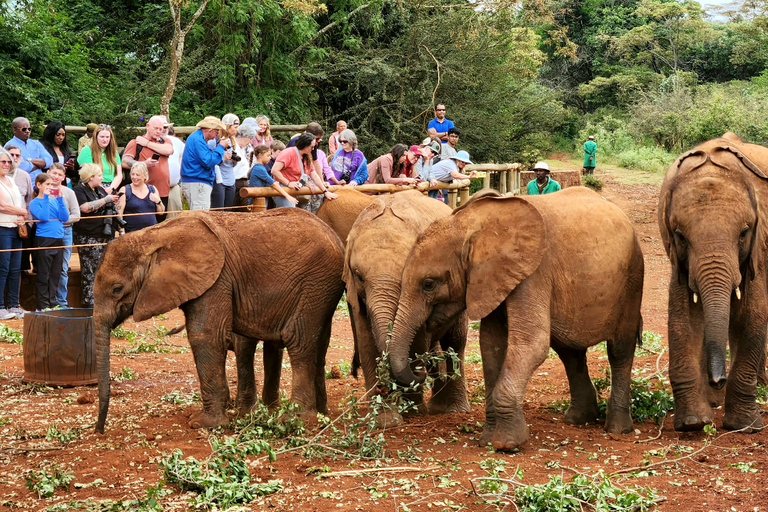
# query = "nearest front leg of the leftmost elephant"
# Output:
<box><xmin>183</xmin><ymin>298</ymin><xmax>231</xmax><ymax>428</ymax></box>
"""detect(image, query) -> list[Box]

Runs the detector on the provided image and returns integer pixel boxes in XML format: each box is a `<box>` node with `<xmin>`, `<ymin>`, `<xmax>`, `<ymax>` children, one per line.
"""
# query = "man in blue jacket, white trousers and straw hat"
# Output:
<box><xmin>181</xmin><ymin>116</ymin><xmax>229</xmax><ymax>210</ymax></box>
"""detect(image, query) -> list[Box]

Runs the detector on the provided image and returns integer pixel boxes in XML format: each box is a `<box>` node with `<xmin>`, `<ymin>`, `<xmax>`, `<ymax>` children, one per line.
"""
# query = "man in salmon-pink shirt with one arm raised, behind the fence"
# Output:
<box><xmin>123</xmin><ymin>116</ymin><xmax>173</xmax><ymax>222</ymax></box>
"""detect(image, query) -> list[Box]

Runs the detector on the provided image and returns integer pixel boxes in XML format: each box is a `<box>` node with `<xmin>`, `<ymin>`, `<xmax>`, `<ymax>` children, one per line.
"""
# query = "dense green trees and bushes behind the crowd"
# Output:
<box><xmin>0</xmin><ymin>0</ymin><xmax>768</xmax><ymax>164</ymax></box>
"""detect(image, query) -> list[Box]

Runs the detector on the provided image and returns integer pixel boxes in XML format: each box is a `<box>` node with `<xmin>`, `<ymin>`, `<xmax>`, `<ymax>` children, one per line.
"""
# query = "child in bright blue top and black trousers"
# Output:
<box><xmin>29</xmin><ymin>173</ymin><xmax>69</xmax><ymax>311</ymax></box>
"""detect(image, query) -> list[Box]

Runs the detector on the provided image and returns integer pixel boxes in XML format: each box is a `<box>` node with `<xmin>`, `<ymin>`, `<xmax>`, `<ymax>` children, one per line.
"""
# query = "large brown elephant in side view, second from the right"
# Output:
<box><xmin>390</xmin><ymin>187</ymin><xmax>643</xmax><ymax>450</ymax></box>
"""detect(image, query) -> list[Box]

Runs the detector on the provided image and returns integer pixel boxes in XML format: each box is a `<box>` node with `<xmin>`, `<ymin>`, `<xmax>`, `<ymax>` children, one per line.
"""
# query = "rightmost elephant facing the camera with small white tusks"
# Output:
<box><xmin>659</xmin><ymin>133</ymin><xmax>768</xmax><ymax>432</ymax></box>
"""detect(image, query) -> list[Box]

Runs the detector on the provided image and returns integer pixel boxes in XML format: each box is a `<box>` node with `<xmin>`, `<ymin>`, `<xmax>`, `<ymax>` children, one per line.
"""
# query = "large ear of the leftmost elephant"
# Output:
<box><xmin>133</xmin><ymin>213</ymin><xmax>225</xmax><ymax>322</ymax></box>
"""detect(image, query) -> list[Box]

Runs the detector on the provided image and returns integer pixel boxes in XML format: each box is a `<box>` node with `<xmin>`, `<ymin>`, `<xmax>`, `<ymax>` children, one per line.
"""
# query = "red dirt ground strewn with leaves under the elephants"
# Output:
<box><xmin>0</xmin><ymin>175</ymin><xmax>768</xmax><ymax>512</ymax></box>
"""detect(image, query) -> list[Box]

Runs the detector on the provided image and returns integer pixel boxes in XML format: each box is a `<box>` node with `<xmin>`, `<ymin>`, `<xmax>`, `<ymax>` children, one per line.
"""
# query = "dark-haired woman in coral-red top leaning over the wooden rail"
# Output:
<box><xmin>272</xmin><ymin>132</ymin><xmax>339</xmax><ymax>208</ymax></box>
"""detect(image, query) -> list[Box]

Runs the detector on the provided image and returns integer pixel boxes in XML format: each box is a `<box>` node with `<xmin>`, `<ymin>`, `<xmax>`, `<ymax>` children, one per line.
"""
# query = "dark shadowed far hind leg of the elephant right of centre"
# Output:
<box><xmin>551</xmin><ymin>344</ymin><xmax>599</xmax><ymax>425</ymax></box>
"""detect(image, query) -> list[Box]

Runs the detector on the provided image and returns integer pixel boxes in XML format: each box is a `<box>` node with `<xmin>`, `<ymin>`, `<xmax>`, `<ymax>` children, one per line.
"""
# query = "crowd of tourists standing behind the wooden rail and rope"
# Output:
<box><xmin>0</xmin><ymin>104</ymin><xmax>486</xmax><ymax>320</ymax></box>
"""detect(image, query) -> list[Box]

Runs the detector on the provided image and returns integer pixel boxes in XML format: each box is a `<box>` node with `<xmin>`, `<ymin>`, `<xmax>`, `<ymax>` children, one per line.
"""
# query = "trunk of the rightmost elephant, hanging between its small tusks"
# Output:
<box><xmin>699</xmin><ymin>272</ymin><xmax>733</xmax><ymax>389</ymax></box>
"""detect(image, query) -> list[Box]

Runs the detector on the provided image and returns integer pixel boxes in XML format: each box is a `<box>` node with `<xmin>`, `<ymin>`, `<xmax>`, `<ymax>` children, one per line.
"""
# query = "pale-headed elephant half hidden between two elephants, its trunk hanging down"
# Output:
<box><xmin>344</xmin><ymin>190</ymin><xmax>469</xmax><ymax>425</ymax></box>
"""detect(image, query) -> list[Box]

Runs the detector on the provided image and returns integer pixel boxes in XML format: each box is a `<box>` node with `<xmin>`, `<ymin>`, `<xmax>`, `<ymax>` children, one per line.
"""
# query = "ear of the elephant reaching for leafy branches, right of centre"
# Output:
<box><xmin>457</xmin><ymin>197</ymin><xmax>547</xmax><ymax>319</ymax></box>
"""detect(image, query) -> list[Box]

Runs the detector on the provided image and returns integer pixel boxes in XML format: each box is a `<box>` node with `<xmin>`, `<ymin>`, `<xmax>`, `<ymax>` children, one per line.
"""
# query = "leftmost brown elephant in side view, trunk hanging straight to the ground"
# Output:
<box><xmin>93</xmin><ymin>208</ymin><xmax>344</xmax><ymax>433</ymax></box>
